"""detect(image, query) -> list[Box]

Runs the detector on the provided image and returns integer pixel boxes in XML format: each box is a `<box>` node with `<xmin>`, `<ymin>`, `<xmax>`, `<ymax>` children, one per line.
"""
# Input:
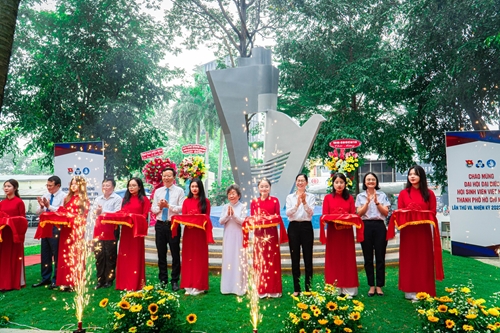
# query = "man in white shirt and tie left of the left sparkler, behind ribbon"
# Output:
<box><xmin>32</xmin><ymin>176</ymin><xmax>66</xmax><ymax>289</ymax></box>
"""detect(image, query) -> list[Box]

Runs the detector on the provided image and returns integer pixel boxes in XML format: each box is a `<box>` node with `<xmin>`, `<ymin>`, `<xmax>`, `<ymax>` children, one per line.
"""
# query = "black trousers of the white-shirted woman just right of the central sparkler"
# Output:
<box><xmin>288</xmin><ymin>221</ymin><xmax>314</xmax><ymax>292</ymax></box>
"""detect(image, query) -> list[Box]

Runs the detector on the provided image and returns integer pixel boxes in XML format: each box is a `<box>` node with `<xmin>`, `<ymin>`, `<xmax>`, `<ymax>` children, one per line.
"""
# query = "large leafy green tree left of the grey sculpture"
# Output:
<box><xmin>0</xmin><ymin>0</ymin><xmax>178</xmax><ymax>175</ymax></box>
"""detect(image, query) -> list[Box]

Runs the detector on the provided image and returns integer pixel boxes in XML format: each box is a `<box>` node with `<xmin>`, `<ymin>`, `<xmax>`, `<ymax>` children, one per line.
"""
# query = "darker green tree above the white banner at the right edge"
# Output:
<box><xmin>399</xmin><ymin>0</ymin><xmax>500</xmax><ymax>183</ymax></box>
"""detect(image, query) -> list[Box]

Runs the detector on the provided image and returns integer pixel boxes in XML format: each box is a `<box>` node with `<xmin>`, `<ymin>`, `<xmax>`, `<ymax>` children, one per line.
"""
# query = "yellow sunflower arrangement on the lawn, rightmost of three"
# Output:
<box><xmin>416</xmin><ymin>285</ymin><xmax>500</xmax><ymax>333</ymax></box>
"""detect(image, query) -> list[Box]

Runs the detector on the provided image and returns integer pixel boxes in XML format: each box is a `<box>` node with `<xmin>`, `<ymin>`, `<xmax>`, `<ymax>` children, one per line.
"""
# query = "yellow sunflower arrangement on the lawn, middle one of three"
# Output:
<box><xmin>281</xmin><ymin>284</ymin><xmax>365</xmax><ymax>333</ymax></box>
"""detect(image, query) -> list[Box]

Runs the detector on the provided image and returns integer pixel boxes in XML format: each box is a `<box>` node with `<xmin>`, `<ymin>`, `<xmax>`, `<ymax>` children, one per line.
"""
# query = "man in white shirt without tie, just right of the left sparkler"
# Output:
<box><xmin>91</xmin><ymin>178</ymin><xmax>122</xmax><ymax>289</ymax></box>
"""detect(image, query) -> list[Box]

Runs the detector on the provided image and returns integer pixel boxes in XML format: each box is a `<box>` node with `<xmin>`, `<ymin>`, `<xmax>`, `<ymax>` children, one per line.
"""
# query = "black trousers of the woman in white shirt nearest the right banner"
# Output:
<box><xmin>361</xmin><ymin>220</ymin><xmax>387</xmax><ymax>287</ymax></box>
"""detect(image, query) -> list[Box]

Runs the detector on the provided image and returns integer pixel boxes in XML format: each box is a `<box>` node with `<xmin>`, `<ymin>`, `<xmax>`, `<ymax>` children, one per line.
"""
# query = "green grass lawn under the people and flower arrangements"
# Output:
<box><xmin>0</xmin><ymin>252</ymin><xmax>500</xmax><ymax>333</ymax></box>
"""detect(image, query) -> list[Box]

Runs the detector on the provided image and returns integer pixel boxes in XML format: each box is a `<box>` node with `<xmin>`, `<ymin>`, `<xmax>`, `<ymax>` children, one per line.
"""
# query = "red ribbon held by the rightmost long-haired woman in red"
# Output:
<box><xmin>387</xmin><ymin>209</ymin><xmax>444</xmax><ymax>281</ymax></box>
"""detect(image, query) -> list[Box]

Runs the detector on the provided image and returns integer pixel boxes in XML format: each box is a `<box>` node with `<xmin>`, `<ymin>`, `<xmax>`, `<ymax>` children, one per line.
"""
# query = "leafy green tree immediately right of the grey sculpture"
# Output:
<box><xmin>276</xmin><ymin>0</ymin><xmax>414</xmax><ymax>174</ymax></box>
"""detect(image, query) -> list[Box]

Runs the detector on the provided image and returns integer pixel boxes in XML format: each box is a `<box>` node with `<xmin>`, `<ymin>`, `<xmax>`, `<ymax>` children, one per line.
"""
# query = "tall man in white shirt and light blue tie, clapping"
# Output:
<box><xmin>151</xmin><ymin>168</ymin><xmax>186</xmax><ymax>291</ymax></box>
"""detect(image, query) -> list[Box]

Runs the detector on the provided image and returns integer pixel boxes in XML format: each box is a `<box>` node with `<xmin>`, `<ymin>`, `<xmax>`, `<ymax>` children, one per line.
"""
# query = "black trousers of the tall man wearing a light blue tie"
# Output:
<box><xmin>155</xmin><ymin>220</ymin><xmax>181</xmax><ymax>284</ymax></box>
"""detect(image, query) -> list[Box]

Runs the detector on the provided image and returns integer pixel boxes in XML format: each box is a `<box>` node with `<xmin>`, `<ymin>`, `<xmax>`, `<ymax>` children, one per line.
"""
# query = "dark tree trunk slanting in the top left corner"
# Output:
<box><xmin>0</xmin><ymin>0</ymin><xmax>21</xmax><ymax>113</ymax></box>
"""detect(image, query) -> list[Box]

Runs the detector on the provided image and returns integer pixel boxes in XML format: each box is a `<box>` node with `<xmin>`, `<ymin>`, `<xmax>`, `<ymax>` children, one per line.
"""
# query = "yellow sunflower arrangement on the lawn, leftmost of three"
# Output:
<box><xmin>99</xmin><ymin>285</ymin><xmax>197</xmax><ymax>333</ymax></box>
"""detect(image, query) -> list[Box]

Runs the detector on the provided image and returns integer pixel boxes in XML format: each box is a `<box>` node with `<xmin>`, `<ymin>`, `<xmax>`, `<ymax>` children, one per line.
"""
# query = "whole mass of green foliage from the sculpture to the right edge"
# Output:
<box><xmin>276</xmin><ymin>0</ymin><xmax>500</xmax><ymax>184</ymax></box>
